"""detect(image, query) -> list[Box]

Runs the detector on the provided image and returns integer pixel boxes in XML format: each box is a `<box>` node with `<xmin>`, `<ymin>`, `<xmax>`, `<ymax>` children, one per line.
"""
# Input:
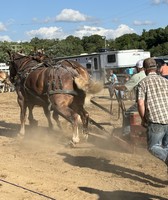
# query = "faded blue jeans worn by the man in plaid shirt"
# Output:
<box><xmin>147</xmin><ymin>123</ymin><xmax>168</xmax><ymax>162</ymax></box>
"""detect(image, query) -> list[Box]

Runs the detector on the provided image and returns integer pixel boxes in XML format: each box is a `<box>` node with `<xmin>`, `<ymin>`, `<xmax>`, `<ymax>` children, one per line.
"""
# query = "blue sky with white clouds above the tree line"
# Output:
<box><xmin>0</xmin><ymin>0</ymin><xmax>168</xmax><ymax>42</ymax></box>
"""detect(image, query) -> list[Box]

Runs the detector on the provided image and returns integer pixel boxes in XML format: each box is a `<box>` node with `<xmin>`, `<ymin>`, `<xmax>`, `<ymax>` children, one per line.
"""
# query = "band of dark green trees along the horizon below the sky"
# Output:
<box><xmin>0</xmin><ymin>26</ymin><xmax>168</xmax><ymax>62</ymax></box>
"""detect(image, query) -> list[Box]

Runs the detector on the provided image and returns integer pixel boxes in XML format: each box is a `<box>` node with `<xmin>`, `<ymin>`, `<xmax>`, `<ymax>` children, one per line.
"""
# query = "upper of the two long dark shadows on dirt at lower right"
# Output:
<box><xmin>59</xmin><ymin>153</ymin><xmax>168</xmax><ymax>188</ymax></box>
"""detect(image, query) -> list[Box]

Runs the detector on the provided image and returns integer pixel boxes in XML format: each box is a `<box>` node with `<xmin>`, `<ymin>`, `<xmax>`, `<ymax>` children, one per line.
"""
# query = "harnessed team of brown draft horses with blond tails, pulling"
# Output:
<box><xmin>8</xmin><ymin>52</ymin><xmax>100</xmax><ymax>143</ymax></box>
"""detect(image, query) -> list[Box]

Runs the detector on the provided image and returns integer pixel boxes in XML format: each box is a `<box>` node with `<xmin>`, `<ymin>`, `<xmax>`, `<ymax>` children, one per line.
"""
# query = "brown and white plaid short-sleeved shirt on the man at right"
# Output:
<box><xmin>137</xmin><ymin>72</ymin><xmax>168</xmax><ymax>124</ymax></box>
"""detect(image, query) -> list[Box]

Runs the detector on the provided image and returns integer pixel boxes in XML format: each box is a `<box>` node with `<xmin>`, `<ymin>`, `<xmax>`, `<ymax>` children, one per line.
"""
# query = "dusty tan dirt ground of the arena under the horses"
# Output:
<box><xmin>0</xmin><ymin>91</ymin><xmax>168</xmax><ymax>200</ymax></box>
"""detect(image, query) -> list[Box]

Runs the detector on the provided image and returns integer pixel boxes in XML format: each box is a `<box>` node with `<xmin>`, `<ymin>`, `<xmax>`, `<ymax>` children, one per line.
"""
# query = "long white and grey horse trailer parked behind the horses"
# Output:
<box><xmin>54</xmin><ymin>49</ymin><xmax>150</xmax><ymax>82</ymax></box>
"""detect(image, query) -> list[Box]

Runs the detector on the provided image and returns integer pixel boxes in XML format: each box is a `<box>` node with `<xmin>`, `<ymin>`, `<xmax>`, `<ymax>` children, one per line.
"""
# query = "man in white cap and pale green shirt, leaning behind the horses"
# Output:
<box><xmin>115</xmin><ymin>60</ymin><xmax>146</xmax><ymax>136</ymax></box>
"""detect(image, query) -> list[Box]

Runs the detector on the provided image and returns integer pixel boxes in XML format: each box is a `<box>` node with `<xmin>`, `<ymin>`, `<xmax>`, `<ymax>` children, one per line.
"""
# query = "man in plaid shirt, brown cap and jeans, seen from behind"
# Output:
<box><xmin>137</xmin><ymin>58</ymin><xmax>168</xmax><ymax>169</ymax></box>
